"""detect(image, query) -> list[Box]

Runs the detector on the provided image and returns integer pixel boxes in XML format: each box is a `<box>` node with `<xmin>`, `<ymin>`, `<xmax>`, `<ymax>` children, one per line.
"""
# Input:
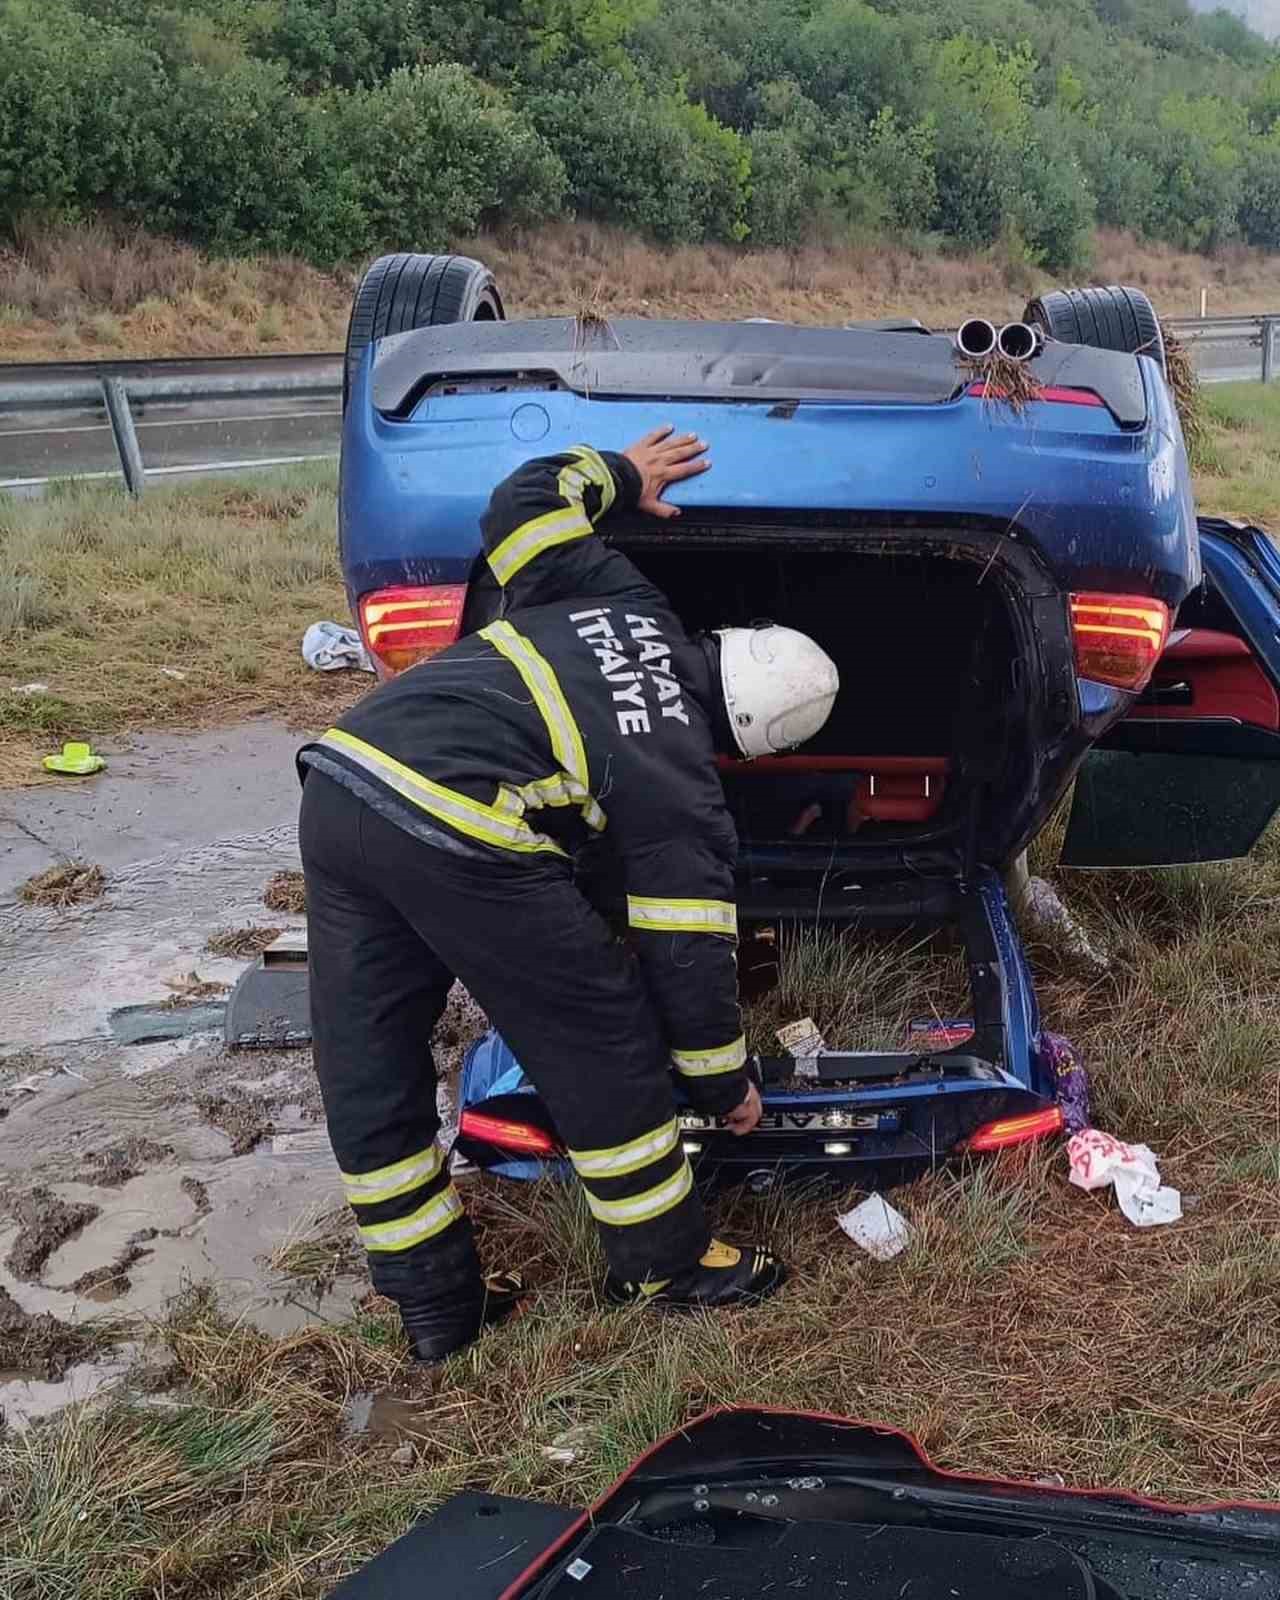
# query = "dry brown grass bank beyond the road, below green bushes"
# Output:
<box><xmin>0</xmin><ymin>222</ymin><xmax>1275</xmax><ymax>360</ymax></box>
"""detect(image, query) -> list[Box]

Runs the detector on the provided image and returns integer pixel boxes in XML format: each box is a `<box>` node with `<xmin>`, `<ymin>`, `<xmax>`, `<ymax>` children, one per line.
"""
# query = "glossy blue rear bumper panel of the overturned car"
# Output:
<box><xmin>339</xmin><ymin>354</ymin><xmax>1200</xmax><ymax>608</ymax></box>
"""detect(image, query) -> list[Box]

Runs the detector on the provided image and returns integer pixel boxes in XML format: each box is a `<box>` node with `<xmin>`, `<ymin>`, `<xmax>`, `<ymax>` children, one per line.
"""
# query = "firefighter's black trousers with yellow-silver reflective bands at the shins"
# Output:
<box><xmin>299</xmin><ymin>771</ymin><xmax>709</xmax><ymax>1298</ymax></box>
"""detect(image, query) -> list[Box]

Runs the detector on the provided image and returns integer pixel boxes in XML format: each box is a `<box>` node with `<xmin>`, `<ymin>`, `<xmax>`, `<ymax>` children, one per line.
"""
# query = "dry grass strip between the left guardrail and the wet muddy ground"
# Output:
<box><xmin>0</xmin><ymin>467</ymin><xmax>360</xmax><ymax>784</ymax></box>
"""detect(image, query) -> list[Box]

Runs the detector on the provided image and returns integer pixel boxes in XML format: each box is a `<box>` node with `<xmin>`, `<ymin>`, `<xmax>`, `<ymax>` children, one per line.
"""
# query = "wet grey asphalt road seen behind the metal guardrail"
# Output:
<box><xmin>0</xmin><ymin>344</ymin><xmax>1259</xmax><ymax>493</ymax></box>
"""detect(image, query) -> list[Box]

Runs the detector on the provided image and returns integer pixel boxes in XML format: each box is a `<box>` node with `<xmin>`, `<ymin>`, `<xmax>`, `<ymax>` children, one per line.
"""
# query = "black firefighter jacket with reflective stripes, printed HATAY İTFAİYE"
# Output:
<box><xmin>301</xmin><ymin>446</ymin><xmax>747</xmax><ymax>1114</ymax></box>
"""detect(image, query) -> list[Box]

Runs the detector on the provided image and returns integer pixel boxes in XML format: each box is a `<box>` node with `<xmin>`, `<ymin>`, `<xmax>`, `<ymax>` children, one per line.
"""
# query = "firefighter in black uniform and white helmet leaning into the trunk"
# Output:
<box><xmin>299</xmin><ymin>427</ymin><xmax>837</xmax><ymax>1362</ymax></box>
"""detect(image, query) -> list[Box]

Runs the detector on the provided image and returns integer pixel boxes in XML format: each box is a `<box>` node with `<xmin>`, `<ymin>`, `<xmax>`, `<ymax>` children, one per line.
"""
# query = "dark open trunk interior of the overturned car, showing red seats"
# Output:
<box><xmin>627</xmin><ymin>539</ymin><xmax>1027</xmax><ymax>851</ymax></box>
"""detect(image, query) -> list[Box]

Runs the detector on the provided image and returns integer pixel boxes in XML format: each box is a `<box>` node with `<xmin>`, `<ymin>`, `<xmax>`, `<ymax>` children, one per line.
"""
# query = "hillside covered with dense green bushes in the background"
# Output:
<box><xmin>0</xmin><ymin>0</ymin><xmax>1280</xmax><ymax>270</ymax></box>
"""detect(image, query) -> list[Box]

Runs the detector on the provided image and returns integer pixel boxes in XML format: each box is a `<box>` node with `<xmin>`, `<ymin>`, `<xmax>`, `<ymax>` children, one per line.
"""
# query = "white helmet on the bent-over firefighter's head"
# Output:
<box><xmin>717</xmin><ymin>622</ymin><xmax>840</xmax><ymax>760</ymax></box>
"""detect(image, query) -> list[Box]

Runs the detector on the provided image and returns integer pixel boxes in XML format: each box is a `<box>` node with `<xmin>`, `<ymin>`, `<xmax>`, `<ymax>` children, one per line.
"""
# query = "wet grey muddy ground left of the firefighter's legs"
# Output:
<box><xmin>0</xmin><ymin>723</ymin><xmax>480</xmax><ymax>1424</ymax></box>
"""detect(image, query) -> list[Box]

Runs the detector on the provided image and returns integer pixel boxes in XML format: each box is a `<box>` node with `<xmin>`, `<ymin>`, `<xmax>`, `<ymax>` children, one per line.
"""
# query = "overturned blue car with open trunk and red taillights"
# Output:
<box><xmin>341</xmin><ymin>256</ymin><xmax>1280</xmax><ymax>1178</ymax></box>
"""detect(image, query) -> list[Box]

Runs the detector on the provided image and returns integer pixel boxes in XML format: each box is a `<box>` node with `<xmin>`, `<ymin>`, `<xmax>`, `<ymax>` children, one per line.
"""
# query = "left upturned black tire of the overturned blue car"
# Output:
<box><xmin>342</xmin><ymin>253</ymin><xmax>507</xmax><ymax>411</ymax></box>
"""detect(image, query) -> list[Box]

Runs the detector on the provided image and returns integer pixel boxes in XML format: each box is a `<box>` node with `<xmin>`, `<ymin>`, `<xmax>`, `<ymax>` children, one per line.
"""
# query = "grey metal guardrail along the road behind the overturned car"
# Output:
<box><xmin>0</xmin><ymin>312</ymin><xmax>1280</xmax><ymax>494</ymax></box>
